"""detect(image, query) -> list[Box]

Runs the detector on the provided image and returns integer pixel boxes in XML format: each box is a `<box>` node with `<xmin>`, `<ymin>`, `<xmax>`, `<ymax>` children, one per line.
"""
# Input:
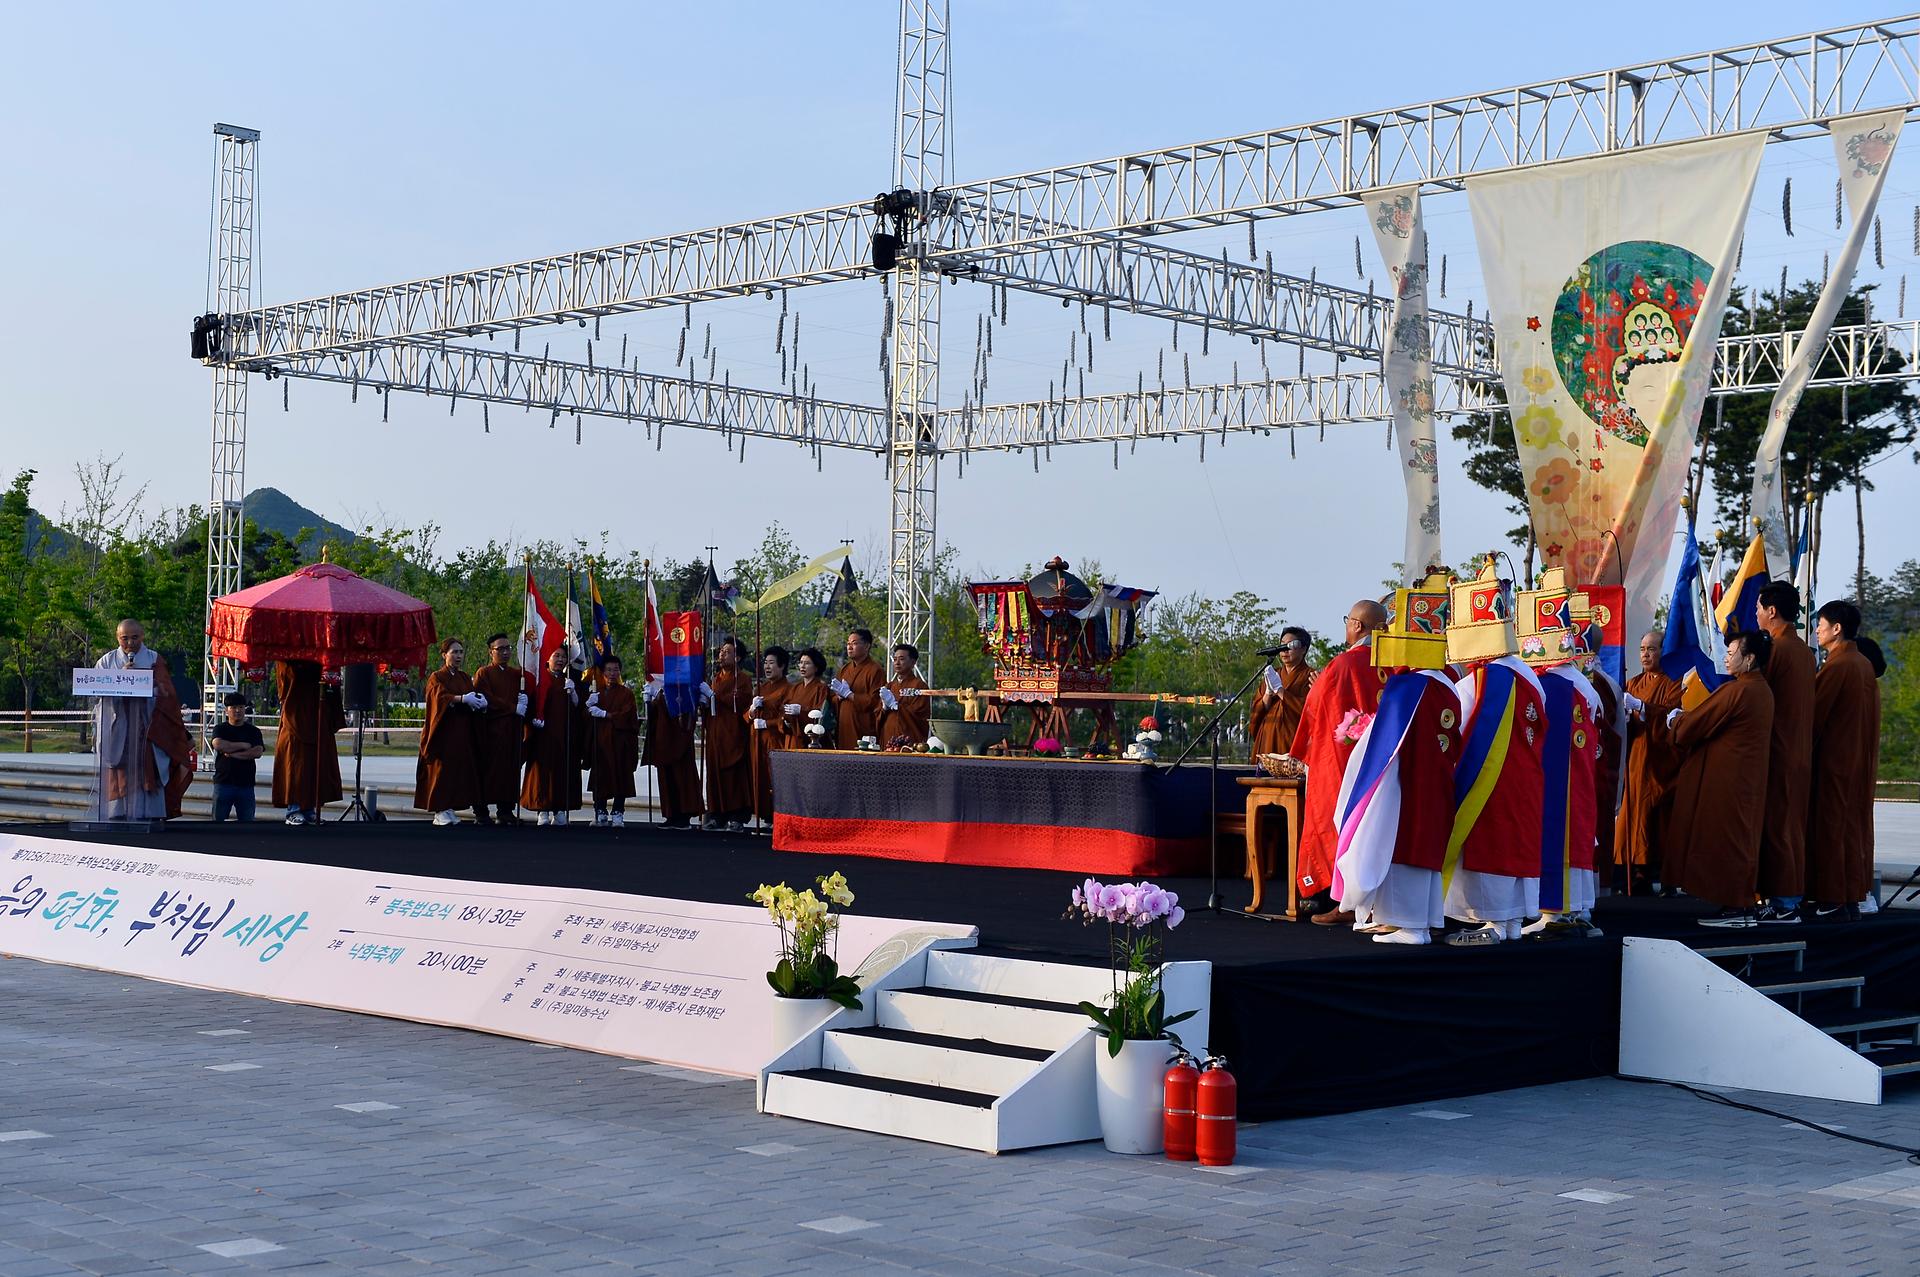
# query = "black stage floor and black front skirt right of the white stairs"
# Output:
<box><xmin>12</xmin><ymin>824</ymin><xmax>1920</xmax><ymax>1120</ymax></box>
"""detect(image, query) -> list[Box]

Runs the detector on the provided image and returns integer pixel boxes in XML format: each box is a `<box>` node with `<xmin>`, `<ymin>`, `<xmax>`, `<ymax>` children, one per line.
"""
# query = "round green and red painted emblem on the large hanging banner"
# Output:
<box><xmin>1551</xmin><ymin>240</ymin><xmax>1713</xmax><ymax>446</ymax></box>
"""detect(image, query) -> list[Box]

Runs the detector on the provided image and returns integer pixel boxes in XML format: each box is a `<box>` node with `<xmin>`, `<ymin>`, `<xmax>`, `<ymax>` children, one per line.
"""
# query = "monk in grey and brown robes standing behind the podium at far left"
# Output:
<box><xmin>94</xmin><ymin>618</ymin><xmax>198</xmax><ymax>820</ymax></box>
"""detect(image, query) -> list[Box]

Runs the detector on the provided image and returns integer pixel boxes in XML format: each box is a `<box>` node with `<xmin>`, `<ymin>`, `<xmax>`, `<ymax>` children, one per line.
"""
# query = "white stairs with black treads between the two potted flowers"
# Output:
<box><xmin>758</xmin><ymin>949</ymin><xmax>1212</xmax><ymax>1152</ymax></box>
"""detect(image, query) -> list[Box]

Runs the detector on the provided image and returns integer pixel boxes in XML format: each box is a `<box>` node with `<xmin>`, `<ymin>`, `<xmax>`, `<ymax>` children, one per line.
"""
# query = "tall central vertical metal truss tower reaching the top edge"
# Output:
<box><xmin>887</xmin><ymin>0</ymin><xmax>952</xmax><ymax>678</ymax></box>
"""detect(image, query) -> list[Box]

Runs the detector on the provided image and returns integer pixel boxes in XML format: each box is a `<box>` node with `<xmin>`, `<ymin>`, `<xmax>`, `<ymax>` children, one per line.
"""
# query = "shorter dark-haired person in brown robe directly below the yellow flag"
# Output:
<box><xmin>1667</xmin><ymin>630</ymin><xmax>1774</xmax><ymax>928</ymax></box>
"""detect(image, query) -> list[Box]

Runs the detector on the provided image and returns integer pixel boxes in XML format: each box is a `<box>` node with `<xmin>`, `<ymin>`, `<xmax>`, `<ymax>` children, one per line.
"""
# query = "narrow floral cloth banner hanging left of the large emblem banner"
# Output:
<box><xmin>1367</xmin><ymin>186</ymin><xmax>1444</xmax><ymax>586</ymax></box>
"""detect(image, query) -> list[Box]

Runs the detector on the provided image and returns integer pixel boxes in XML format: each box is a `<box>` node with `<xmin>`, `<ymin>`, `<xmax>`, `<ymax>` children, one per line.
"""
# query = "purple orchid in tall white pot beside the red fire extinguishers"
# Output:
<box><xmin>1068</xmin><ymin>878</ymin><xmax>1196</xmax><ymax>1152</ymax></box>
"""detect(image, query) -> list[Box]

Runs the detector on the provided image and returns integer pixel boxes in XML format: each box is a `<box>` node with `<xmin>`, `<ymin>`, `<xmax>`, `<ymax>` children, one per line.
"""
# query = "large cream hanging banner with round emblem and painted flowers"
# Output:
<box><xmin>1467</xmin><ymin>136</ymin><xmax>1764</xmax><ymax>649</ymax></box>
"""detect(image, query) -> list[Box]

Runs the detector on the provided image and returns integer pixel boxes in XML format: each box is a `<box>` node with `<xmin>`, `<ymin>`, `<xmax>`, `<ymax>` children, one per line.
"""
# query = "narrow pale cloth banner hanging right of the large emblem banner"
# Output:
<box><xmin>1741</xmin><ymin>109</ymin><xmax>1907</xmax><ymax>580</ymax></box>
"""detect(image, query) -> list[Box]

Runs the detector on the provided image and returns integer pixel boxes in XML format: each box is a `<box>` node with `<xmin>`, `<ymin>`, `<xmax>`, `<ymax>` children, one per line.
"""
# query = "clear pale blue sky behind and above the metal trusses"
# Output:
<box><xmin>0</xmin><ymin>0</ymin><xmax>1920</xmax><ymax>630</ymax></box>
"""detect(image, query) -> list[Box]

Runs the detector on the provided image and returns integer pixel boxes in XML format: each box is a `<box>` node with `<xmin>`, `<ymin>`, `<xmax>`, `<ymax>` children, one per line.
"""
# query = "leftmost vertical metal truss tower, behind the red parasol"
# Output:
<box><xmin>200</xmin><ymin>125</ymin><xmax>259</xmax><ymax>751</ymax></box>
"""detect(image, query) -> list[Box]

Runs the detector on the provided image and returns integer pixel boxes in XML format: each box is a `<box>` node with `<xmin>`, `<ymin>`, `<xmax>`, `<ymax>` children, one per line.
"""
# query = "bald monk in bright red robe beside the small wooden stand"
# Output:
<box><xmin>1292</xmin><ymin>599</ymin><xmax>1386</xmax><ymax>926</ymax></box>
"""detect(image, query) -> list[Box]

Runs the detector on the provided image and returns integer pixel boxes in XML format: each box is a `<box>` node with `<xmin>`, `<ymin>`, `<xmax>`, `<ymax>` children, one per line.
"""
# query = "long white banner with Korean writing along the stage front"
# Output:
<box><xmin>0</xmin><ymin>833</ymin><xmax>977</xmax><ymax>1077</ymax></box>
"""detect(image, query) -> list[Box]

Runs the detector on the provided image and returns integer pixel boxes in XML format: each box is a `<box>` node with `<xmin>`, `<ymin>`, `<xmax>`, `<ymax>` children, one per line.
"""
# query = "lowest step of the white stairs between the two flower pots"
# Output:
<box><xmin>764</xmin><ymin>1068</ymin><xmax>1000</xmax><ymax>1152</ymax></box>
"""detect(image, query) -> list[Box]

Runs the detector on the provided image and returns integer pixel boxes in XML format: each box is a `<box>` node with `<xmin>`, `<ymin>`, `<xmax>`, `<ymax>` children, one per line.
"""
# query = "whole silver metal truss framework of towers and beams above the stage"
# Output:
<box><xmin>207</xmin><ymin>12</ymin><xmax>1920</xmax><ymax>675</ymax></box>
